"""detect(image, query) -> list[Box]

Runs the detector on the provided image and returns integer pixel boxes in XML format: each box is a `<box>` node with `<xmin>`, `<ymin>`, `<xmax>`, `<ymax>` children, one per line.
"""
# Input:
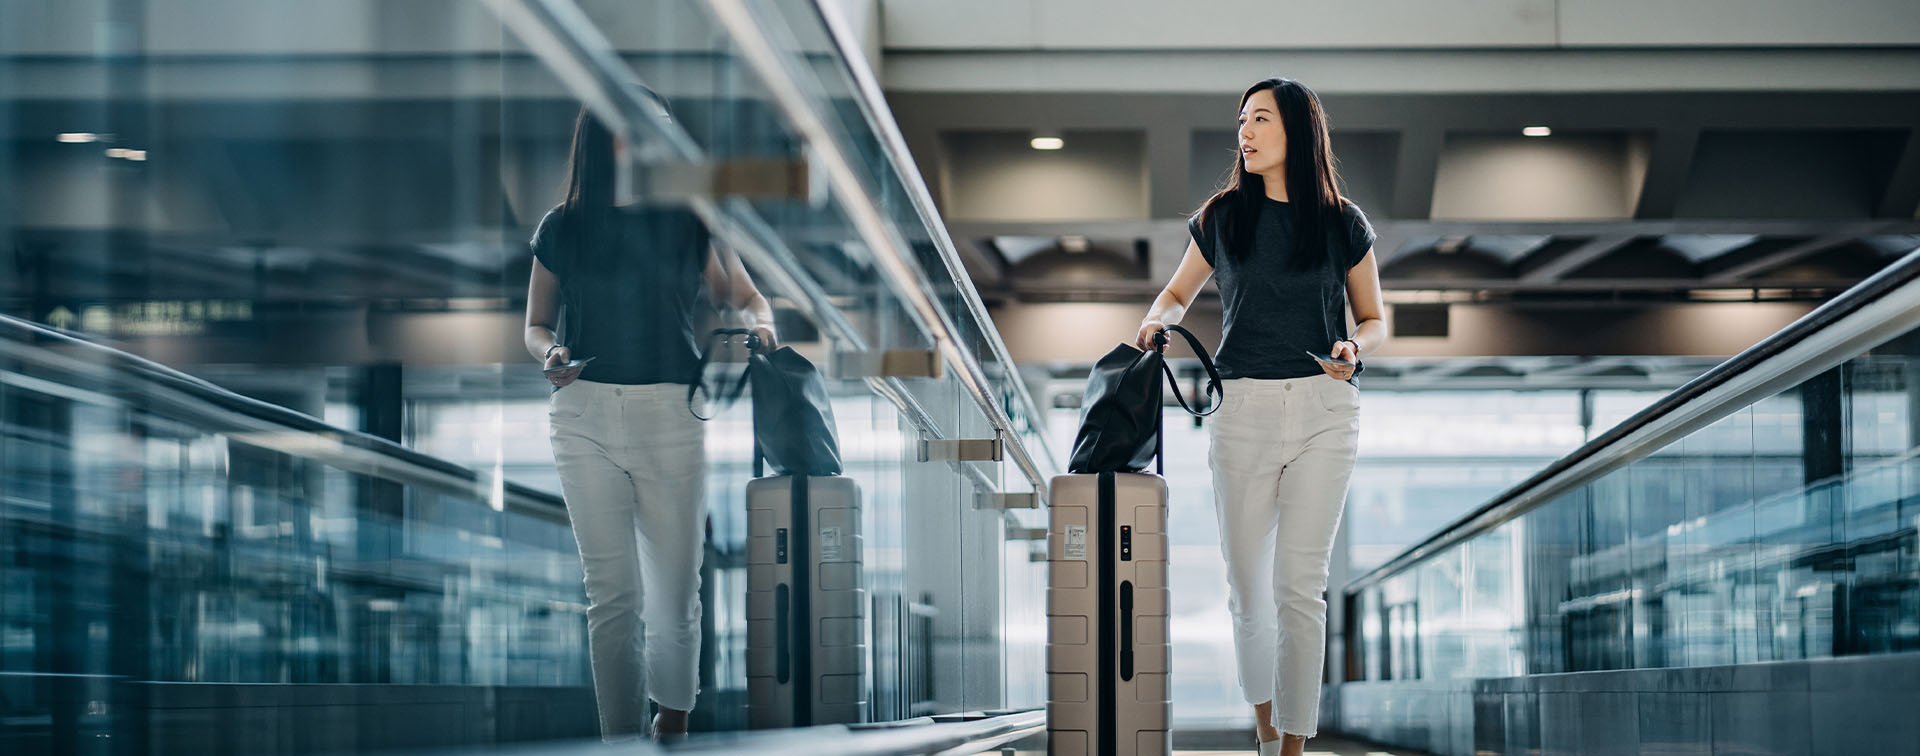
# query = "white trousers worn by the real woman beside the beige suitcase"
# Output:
<box><xmin>1208</xmin><ymin>376</ymin><xmax>1359</xmax><ymax>737</ymax></box>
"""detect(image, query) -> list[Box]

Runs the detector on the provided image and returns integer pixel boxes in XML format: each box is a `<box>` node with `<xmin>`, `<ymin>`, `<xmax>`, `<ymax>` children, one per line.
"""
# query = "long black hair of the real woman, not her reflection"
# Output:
<box><xmin>1200</xmin><ymin>79</ymin><xmax>1346</xmax><ymax>269</ymax></box>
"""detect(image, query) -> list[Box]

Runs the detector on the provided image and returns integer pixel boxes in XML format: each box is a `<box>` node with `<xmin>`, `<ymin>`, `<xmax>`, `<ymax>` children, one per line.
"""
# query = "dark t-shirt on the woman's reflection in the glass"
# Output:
<box><xmin>532</xmin><ymin>205</ymin><xmax>708</xmax><ymax>386</ymax></box>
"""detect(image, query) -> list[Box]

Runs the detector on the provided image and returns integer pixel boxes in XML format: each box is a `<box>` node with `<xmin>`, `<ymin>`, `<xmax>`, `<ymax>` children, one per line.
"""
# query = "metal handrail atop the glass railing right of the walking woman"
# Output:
<box><xmin>1346</xmin><ymin>249</ymin><xmax>1920</xmax><ymax>595</ymax></box>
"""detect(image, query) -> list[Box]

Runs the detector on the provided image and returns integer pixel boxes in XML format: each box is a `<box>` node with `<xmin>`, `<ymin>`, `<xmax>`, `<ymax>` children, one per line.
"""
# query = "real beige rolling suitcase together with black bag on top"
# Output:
<box><xmin>1046</xmin><ymin>326</ymin><xmax>1221</xmax><ymax>756</ymax></box>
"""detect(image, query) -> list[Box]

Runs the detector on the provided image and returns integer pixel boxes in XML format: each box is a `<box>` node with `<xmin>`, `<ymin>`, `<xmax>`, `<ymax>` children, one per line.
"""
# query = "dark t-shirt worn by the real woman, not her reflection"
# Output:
<box><xmin>1187</xmin><ymin>198</ymin><xmax>1375</xmax><ymax>380</ymax></box>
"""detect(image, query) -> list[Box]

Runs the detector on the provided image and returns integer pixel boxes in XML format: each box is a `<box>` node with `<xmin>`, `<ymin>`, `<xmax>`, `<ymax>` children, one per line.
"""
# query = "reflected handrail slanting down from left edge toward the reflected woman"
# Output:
<box><xmin>0</xmin><ymin>315</ymin><xmax>566</xmax><ymax>524</ymax></box>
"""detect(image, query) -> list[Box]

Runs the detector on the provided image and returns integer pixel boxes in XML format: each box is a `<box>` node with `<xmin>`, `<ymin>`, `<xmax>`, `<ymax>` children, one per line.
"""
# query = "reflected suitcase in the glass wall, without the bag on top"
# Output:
<box><xmin>747</xmin><ymin>476</ymin><xmax>868</xmax><ymax>727</ymax></box>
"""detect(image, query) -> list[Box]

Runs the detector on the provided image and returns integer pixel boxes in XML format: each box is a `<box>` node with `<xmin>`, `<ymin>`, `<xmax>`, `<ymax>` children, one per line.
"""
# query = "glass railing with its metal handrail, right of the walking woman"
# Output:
<box><xmin>1346</xmin><ymin>244</ymin><xmax>1920</xmax><ymax>679</ymax></box>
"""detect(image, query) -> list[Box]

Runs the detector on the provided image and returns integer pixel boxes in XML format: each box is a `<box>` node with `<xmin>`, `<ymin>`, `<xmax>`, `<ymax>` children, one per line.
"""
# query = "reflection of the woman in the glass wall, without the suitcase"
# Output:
<box><xmin>526</xmin><ymin>100</ymin><xmax>774</xmax><ymax>741</ymax></box>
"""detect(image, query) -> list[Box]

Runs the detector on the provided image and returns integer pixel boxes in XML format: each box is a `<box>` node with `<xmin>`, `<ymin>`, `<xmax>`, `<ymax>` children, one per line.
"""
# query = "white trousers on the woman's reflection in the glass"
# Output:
<box><xmin>547</xmin><ymin>380</ymin><xmax>707</xmax><ymax>739</ymax></box>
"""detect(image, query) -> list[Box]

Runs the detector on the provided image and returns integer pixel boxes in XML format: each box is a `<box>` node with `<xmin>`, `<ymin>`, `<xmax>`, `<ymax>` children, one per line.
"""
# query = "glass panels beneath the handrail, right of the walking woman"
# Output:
<box><xmin>1352</xmin><ymin>334</ymin><xmax>1920</xmax><ymax>679</ymax></box>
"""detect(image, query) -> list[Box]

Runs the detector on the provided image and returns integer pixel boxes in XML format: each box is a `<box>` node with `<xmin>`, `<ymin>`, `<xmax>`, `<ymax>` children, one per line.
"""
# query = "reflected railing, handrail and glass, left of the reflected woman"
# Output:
<box><xmin>0</xmin><ymin>319</ymin><xmax>588</xmax><ymax>686</ymax></box>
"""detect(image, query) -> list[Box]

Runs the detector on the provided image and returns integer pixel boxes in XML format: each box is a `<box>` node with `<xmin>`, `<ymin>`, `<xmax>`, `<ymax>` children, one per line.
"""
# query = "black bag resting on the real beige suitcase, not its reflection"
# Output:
<box><xmin>1068</xmin><ymin>326</ymin><xmax>1223</xmax><ymax>474</ymax></box>
